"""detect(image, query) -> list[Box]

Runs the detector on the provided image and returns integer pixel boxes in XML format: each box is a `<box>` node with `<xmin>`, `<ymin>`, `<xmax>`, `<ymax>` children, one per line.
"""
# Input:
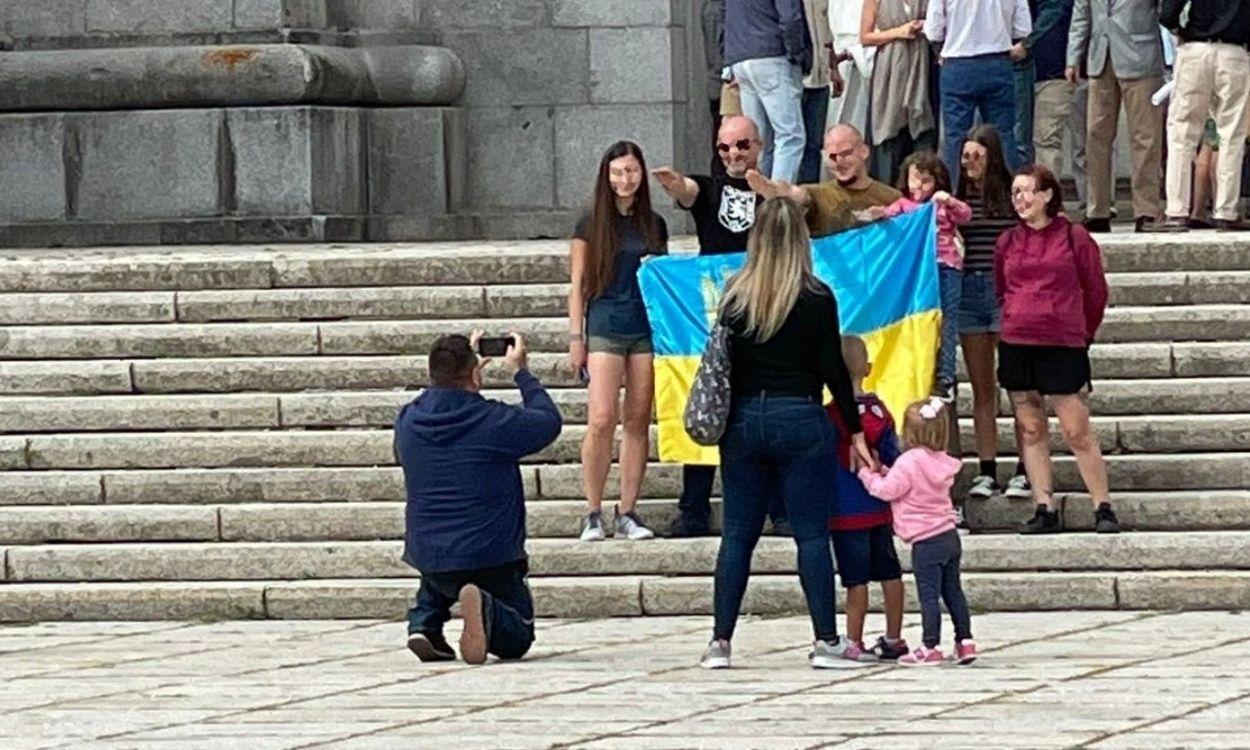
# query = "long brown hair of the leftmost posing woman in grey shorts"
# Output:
<box><xmin>581</xmin><ymin>141</ymin><xmax>660</xmax><ymax>300</ymax></box>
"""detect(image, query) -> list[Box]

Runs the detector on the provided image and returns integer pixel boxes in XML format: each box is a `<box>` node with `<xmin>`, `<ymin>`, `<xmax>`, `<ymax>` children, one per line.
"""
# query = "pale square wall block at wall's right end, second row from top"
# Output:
<box><xmin>588</xmin><ymin>28</ymin><xmax>675</xmax><ymax>104</ymax></box>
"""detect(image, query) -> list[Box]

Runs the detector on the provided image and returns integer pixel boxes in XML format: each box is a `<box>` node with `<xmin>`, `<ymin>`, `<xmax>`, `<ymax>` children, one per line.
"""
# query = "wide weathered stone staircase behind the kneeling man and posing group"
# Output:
<box><xmin>0</xmin><ymin>234</ymin><xmax>1250</xmax><ymax>621</ymax></box>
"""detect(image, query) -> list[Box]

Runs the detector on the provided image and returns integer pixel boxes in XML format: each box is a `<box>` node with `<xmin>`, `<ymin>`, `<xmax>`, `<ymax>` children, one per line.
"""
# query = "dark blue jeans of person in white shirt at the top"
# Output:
<box><xmin>941</xmin><ymin>53</ymin><xmax>1020</xmax><ymax>183</ymax></box>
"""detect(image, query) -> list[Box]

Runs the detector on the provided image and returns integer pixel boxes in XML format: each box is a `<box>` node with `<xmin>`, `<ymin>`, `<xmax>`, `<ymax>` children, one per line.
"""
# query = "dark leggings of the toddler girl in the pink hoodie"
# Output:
<box><xmin>911</xmin><ymin>529</ymin><xmax>973</xmax><ymax>649</ymax></box>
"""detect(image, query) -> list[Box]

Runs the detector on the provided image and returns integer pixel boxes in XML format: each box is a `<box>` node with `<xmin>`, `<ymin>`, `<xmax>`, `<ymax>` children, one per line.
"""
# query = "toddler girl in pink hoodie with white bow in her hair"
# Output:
<box><xmin>859</xmin><ymin>396</ymin><xmax>976</xmax><ymax>666</ymax></box>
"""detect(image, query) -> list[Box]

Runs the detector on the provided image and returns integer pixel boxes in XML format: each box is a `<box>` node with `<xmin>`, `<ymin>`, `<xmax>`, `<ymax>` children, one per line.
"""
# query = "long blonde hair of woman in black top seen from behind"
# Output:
<box><xmin>721</xmin><ymin>198</ymin><xmax>819</xmax><ymax>341</ymax></box>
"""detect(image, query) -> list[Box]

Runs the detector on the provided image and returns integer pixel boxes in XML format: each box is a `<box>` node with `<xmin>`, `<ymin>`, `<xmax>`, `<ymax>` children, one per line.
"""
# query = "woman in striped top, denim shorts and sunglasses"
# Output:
<box><xmin>956</xmin><ymin>125</ymin><xmax>1033</xmax><ymax>507</ymax></box>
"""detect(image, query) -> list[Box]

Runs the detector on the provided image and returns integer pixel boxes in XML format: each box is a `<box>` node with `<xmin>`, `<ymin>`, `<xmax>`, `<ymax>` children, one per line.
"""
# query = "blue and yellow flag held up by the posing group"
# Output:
<box><xmin>638</xmin><ymin>205</ymin><xmax>941</xmax><ymax>464</ymax></box>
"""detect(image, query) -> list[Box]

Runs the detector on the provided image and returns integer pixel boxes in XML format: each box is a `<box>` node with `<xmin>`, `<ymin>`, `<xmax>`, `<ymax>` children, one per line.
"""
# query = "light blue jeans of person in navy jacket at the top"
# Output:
<box><xmin>734</xmin><ymin>58</ymin><xmax>805</xmax><ymax>183</ymax></box>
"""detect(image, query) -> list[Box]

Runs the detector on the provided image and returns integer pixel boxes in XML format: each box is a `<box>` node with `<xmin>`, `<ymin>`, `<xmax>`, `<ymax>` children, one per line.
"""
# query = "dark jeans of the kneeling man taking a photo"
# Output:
<box><xmin>408</xmin><ymin>560</ymin><xmax>534</xmax><ymax>659</ymax></box>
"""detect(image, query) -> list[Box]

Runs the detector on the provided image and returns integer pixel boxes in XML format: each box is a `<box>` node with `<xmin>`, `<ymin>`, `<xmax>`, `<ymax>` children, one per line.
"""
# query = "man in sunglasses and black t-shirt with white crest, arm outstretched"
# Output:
<box><xmin>653</xmin><ymin>115</ymin><xmax>785</xmax><ymax>536</ymax></box>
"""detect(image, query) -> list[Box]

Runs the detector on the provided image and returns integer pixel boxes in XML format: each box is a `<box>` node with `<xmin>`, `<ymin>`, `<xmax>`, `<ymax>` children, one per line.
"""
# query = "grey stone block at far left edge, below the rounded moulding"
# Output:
<box><xmin>0</xmin><ymin>115</ymin><xmax>66</xmax><ymax>221</ymax></box>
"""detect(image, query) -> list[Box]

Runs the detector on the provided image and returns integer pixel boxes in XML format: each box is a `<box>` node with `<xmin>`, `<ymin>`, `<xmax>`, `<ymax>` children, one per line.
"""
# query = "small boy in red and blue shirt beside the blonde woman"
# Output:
<box><xmin>826</xmin><ymin>336</ymin><xmax>908</xmax><ymax>661</ymax></box>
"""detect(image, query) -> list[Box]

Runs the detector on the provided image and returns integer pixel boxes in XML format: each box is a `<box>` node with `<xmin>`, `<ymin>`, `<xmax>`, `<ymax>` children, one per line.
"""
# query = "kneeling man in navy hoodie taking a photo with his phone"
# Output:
<box><xmin>395</xmin><ymin>331</ymin><xmax>561</xmax><ymax>664</ymax></box>
